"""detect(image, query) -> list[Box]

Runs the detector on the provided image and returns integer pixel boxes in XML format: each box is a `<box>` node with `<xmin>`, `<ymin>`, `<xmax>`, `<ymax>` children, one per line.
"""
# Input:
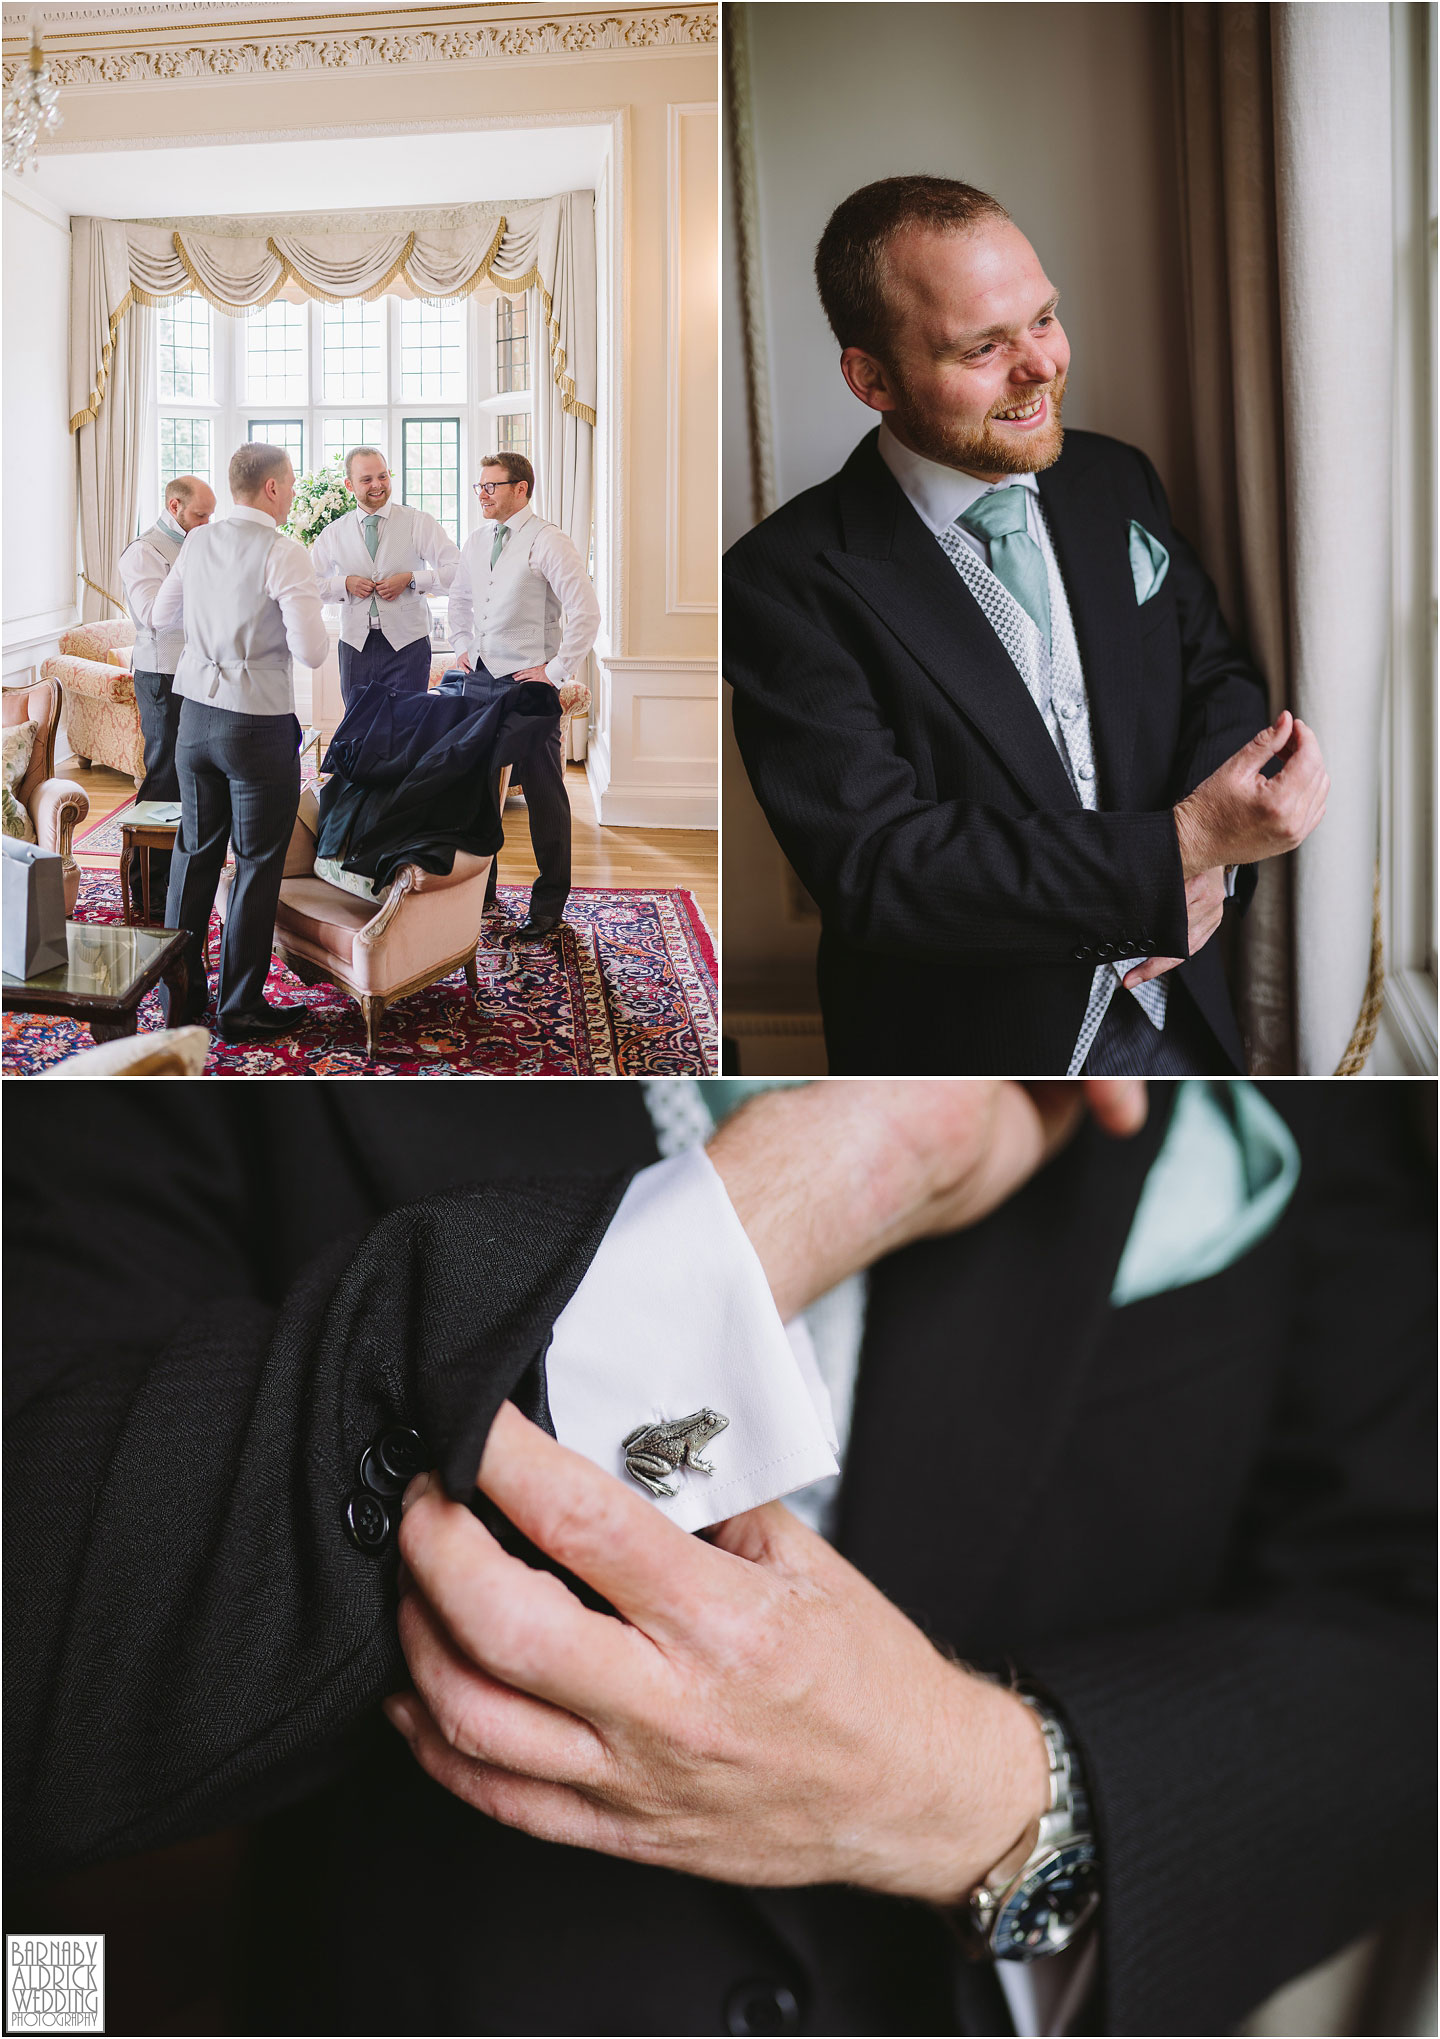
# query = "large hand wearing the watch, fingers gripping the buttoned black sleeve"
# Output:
<box><xmin>385</xmin><ymin>1403</ymin><xmax>1048</xmax><ymax>1902</ymax></box>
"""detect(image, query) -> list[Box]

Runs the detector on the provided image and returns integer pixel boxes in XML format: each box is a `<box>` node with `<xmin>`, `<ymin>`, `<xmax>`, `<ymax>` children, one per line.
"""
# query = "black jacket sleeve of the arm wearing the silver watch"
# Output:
<box><xmin>1024</xmin><ymin>1087</ymin><xmax>1434</xmax><ymax>2033</ymax></box>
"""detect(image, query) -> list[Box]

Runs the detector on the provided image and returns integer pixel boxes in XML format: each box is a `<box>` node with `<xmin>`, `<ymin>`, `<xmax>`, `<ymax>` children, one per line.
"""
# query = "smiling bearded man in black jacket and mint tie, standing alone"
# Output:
<box><xmin>724</xmin><ymin>177</ymin><xmax>1330</xmax><ymax>1075</ymax></box>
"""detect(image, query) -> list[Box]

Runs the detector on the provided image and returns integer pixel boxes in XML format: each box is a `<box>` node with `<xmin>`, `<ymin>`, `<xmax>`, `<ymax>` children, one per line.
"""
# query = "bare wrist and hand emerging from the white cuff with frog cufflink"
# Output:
<box><xmin>708</xmin><ymin>1079</ymin><xmax>1146</xmax><ymax>1317</ymax></box>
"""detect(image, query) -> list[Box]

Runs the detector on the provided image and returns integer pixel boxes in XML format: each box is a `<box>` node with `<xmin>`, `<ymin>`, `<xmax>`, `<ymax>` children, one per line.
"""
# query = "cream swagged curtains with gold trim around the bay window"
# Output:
<box><xmin>69</xmin><ymin>192</ymin><xmax>596</xmax><ymax>583</ymax></box>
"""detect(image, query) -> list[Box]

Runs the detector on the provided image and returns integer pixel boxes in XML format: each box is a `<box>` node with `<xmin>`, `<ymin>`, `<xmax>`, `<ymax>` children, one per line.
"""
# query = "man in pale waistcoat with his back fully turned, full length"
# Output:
<box><xmin>153</xmin><ymin>440</ymin><xmax>328</xmax><ymax>1042</ymax></box>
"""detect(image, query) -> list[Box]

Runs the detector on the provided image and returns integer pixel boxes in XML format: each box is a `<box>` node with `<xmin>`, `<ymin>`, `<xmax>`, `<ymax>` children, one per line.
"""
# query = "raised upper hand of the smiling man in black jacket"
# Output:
<box><xmin>1175</xmin><ymin>708</ymin><xmax>1330</xmax><ymax>879</ymax></box>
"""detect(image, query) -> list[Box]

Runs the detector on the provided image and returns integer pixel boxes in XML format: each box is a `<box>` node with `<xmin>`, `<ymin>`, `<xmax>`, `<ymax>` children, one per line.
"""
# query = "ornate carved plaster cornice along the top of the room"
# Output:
<box><xmin>4</xmin><ymin>6</ymin><xmax>718</xmax><ymax>86</ymax></box>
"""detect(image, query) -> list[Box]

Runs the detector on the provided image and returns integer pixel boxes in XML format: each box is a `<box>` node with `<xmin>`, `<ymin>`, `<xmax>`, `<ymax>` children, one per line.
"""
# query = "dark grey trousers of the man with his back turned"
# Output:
<box><xmin>165</xmin><ymin>699</ymin><xmax>300</xmax><ymax>1026</ymax></box>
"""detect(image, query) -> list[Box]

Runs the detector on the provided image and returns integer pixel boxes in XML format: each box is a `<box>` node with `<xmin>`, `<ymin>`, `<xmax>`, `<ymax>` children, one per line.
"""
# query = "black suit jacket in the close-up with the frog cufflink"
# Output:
<box><xmin>6</xmin><ymin>1083</ymin><xmax>1434</xmax><ymax>2033</ymax></box>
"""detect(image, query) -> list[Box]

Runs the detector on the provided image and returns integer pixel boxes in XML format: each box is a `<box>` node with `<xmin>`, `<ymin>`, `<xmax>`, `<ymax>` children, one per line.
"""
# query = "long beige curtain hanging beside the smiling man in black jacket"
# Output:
<box><xmin>1173</xmin><ymin>0</ymin><xmax>1393</xmax><ymax>1075</ymax></box>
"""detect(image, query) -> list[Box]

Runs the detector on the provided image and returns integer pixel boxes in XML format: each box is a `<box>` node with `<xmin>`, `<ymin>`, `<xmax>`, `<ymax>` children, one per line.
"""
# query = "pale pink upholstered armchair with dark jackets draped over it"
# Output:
<box><xmin>218</xmin><ymin>769</ymin><xmax>510</xmax><ymax>1054</ymax></box>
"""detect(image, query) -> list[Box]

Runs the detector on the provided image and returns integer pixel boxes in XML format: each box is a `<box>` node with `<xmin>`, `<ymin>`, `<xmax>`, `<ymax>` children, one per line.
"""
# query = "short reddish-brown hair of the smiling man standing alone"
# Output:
<box><xmin>816</xmin><ymin>177</ymin><xmax>1010</xmax><ymax>359</ymax></box>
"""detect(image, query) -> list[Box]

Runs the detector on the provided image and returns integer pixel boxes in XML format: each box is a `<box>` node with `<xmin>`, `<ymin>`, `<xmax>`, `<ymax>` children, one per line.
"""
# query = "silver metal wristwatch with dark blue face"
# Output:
<box><xmin>967</xmin><ymin>1690</ymin><xmax>1099</xmax><ymax>1962</ymax></box>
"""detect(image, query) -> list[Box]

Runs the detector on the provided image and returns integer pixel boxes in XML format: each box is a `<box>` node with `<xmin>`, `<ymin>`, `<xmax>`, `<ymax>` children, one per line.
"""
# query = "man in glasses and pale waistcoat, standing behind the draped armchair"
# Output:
<box><xmin>441</xmin><ymin>453</ymin><xmax>600</xmax><ymax>942</ymax></box>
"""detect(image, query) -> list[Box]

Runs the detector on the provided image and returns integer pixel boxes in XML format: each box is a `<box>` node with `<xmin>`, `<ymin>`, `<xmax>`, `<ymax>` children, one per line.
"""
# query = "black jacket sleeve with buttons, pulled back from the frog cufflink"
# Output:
<box><xmin>4</xmin><ymin>1085</ymin><xmax>632</xmax><ymax>1874</ymax></box>
